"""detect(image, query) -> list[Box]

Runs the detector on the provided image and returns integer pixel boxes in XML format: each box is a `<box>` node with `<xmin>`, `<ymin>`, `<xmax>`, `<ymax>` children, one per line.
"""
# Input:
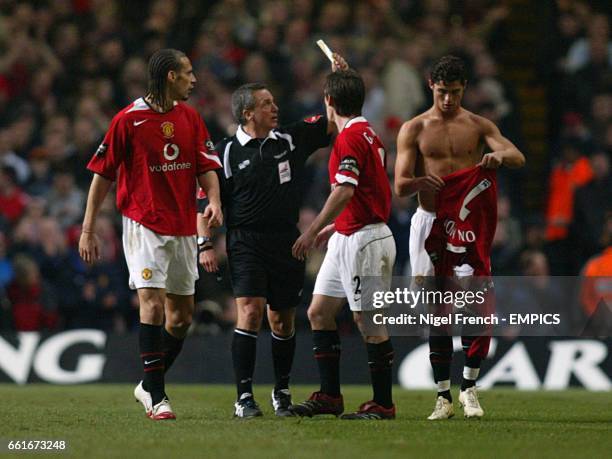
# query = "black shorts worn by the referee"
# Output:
<box><xmin>227</xmin><ymin>229</ymin><xmax>305</xmax><ymax>311</ymax></box>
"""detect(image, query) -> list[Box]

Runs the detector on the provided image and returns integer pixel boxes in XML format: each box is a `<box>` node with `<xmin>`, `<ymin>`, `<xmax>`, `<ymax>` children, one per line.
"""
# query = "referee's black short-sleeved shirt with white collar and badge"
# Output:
<box><xmin>215</xmin><ymin>116</ymin><xmax>330</xmax><ymax>232</ymax></box>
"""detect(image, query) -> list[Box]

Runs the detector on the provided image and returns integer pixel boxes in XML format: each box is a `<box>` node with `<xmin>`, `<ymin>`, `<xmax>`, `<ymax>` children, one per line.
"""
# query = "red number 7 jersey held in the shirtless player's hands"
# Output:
<box><xmin>425</xmin><ymin>166</ymin><xmax>497</xmax><ymax>276</ymax></box>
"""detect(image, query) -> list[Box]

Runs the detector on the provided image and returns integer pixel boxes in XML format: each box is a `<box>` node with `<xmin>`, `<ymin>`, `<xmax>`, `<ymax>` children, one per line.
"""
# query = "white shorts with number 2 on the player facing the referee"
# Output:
<box><xmin>313</xmin><ymin>223</ymin><xmax>395</xmax><ymax>311</ymax></box>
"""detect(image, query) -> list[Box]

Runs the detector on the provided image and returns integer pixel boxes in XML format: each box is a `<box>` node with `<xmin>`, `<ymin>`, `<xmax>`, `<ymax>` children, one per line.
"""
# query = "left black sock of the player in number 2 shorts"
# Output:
<box><xmin>312</xmin><ymin>330</ymin><xmax>340</xmax><ymax>397</ymax></box>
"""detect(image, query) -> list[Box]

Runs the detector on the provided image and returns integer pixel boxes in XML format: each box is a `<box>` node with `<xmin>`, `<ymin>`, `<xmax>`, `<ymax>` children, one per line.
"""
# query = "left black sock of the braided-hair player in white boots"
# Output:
<box><xmin>138</xmin><ymin>323</ymin><xmax>166</xmax><ymax>405</ymax></box>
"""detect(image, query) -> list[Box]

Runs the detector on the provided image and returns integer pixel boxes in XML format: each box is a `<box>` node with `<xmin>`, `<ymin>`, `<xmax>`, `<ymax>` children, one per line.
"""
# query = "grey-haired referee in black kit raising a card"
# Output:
<box><xmin>198</xmin><ymin>55</ymin><xmax>348</xmax><ymax>418</ymax></box>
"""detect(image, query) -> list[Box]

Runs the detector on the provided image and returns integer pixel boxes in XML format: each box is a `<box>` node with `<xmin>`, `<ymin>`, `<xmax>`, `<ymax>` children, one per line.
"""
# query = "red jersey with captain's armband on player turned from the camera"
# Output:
<box><xmin>329</xmin><ymin>116</ymin><xmax>391</xmax><ymax>236</ymax></box>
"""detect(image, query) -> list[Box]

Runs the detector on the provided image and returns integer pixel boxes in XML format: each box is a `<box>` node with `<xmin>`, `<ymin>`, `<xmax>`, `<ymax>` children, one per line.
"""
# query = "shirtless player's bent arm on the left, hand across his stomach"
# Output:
<box><xmin>394</xmin><ymin>119</ymin><xmax>444</xmax><ymax>196</ymax></box>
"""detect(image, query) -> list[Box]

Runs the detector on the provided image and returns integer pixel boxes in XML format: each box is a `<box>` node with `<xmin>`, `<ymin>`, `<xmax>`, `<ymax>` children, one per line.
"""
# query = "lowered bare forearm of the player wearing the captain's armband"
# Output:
<box><xmin>291</xmin><ymin>183</ymin><xmax>355</xmax><ymax>260</ymax></box>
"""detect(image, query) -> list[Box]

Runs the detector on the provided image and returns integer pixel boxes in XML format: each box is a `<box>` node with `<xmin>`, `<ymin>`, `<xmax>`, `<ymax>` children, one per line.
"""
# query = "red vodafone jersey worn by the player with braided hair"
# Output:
<box><xmin>87</xmin><ymin>98</ymin><xmax>221</xmax><ymax>236</ymax></box>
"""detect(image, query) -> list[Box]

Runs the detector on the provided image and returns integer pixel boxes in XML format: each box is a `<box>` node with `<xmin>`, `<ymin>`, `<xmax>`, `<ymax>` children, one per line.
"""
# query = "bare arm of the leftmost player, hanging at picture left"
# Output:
<box><xmin>79</xmin><ymin>174</ymin><xmax>113</xmax><ymax>264</ymax></box>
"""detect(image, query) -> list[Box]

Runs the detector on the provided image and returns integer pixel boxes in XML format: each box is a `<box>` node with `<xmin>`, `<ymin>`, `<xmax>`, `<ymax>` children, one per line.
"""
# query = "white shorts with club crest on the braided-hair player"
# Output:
<box><xmin>123</xmin><ymin>216</ymin><xmax>198</xmax><ymax>295</ymax></box>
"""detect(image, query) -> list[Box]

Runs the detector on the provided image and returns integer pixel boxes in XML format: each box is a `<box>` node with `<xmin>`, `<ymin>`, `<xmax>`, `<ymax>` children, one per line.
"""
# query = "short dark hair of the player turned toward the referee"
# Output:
<box><xmin>325</xmin><ymin>69</ymin><xmax>365</xmax><ymax>116</ymax></box>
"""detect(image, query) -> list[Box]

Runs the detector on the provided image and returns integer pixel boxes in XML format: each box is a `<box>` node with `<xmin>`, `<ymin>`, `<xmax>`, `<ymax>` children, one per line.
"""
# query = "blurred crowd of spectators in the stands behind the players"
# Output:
<box><xmin>0</xmin><ymin>0</ymin><xmax>612</xmax><ymax>332</ymax></box>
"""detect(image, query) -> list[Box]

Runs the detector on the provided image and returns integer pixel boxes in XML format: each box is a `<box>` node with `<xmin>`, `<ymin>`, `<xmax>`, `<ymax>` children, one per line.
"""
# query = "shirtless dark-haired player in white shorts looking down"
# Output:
<box><xmin>395</xmin><ymin>56</ymin><xmax>525</xmax><ymax>420</ymax></box>
